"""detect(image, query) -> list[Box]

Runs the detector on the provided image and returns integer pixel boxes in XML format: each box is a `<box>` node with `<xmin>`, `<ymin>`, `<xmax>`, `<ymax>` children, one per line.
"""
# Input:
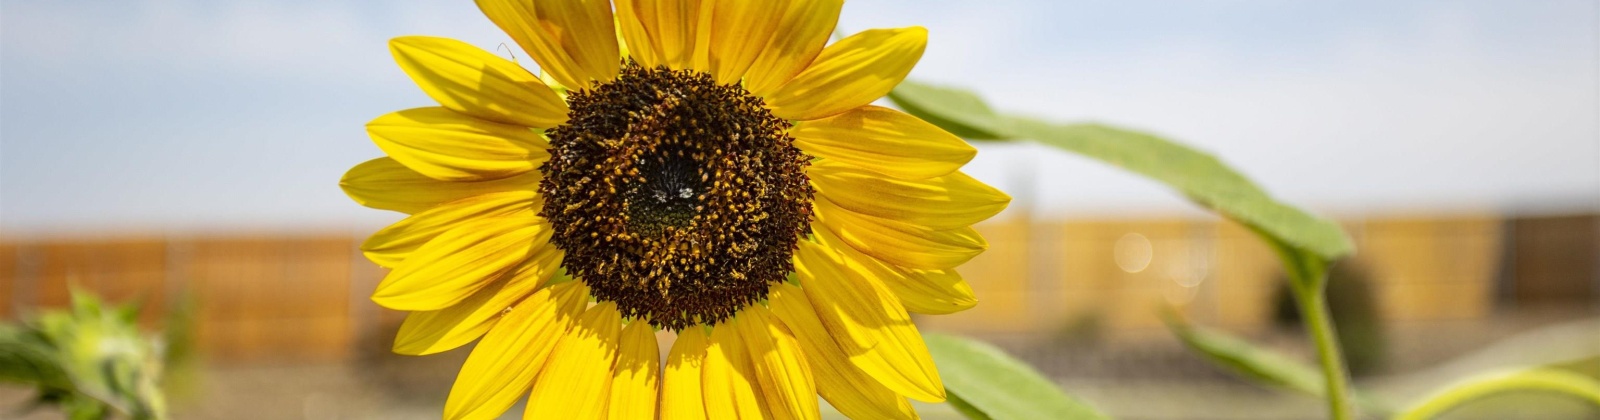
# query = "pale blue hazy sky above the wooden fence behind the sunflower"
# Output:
<box><xmin>0</xmin><ymin>0</ymin><xmax>1600</xmax><ymax>232</ymax></box>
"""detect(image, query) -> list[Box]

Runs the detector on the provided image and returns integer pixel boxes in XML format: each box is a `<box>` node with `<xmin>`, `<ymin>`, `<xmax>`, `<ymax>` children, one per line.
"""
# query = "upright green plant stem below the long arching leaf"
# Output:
<box><xmin>1291</xmin><ymin>278</ymin><xmax>1354</xmax><ymax>420</ymax></box>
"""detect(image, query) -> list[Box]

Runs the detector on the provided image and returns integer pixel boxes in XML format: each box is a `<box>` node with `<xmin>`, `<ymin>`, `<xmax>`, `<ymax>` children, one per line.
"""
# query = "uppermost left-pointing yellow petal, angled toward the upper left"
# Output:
<box><xmin>389</xmin><ymin>37</ymin><xmax>566</xmax><ymax>128</ymax></box>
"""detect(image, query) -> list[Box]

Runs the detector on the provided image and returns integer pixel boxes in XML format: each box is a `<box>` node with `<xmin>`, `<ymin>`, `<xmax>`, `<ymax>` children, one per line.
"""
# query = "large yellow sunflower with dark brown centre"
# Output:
<box><xmin>341</xmin><ymin>0</ymin><xmax>1010</xmax><ymax>418</ymax></box>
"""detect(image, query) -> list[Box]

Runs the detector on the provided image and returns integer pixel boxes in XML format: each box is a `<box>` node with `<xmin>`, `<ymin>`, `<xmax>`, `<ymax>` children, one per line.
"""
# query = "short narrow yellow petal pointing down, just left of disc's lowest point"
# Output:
<box><xmin>606</xmin><ymin>319</ymin><xmax>661</xmax><ymax>420</ymax></box>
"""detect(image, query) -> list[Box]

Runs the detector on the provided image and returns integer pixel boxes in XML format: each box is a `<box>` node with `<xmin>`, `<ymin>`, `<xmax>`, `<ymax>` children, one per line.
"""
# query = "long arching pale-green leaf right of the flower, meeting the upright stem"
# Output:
<box><xmin>1011</xmin><ymin>119</ymin><xmax>1354</xmax><ymax>261</ymax></box>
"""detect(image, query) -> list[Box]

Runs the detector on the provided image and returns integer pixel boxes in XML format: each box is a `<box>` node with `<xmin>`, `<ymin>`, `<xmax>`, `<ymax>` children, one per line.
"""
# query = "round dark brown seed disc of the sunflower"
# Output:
<box><xmin>539</xmin><ymin>64</ymin><xmax>813</xmax><ymax>330</ymax></box>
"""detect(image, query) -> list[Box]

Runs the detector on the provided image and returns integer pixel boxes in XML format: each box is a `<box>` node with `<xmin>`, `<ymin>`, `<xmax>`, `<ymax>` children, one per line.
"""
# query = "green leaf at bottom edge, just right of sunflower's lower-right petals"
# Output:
<box><xmin>923</xmin><ymin>333</ymin><xmax>1106</xmax><ymax>420</ymax></box>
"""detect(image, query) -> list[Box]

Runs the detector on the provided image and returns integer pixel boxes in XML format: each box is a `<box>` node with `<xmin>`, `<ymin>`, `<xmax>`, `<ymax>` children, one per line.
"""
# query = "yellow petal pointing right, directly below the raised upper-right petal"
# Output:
<box><xmin>789</xmin><ymin>106</ymin><xmax>978</xmax><ymax>180</ymax></box>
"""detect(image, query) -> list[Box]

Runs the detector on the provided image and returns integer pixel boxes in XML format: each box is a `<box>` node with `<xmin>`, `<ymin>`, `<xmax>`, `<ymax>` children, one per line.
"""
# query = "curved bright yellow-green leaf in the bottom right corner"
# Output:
<box><xmin>1395</xmin><ymin>369</ymin><xmax>1600</xmax><ymax>420</ymax></box>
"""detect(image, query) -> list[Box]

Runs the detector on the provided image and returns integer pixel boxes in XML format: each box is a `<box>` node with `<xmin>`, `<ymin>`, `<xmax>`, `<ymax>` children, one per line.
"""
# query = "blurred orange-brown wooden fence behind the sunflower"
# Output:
<box><xmin>0</xmin><ymin>215</ymin><xmax>1594</xmax><ymax>361</ymax></box>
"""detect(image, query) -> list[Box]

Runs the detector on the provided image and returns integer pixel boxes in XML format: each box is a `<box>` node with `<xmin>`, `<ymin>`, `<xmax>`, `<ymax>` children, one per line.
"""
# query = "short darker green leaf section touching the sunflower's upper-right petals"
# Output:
<box><xmin>890</xmin><ymin>80</ymin><xmax>1011</xmax><ymax>139</ymax></box>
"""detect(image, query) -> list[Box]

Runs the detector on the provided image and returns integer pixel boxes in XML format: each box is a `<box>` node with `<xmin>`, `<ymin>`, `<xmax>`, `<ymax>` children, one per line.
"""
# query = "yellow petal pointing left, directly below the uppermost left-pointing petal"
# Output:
<box><xmin>366</xmin><ymin>107</ymin><xmax>550</xmax><ymax>181</ymax></box>
